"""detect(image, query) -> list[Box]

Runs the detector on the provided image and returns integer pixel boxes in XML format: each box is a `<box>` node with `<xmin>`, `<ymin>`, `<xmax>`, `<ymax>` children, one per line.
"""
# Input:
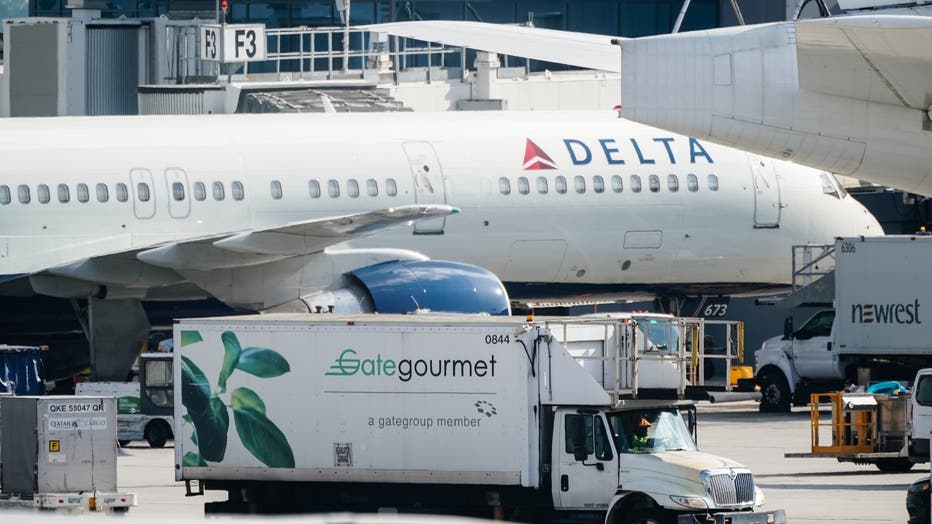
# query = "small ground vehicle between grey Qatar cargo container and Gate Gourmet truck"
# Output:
<box><xmin>75</xmin><ymin>353</ymin><xmax>175</xmax><ymax>448</ymax></box>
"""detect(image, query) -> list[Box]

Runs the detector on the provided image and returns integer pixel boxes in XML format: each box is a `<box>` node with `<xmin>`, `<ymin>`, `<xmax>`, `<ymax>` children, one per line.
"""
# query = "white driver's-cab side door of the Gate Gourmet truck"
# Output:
<box><xmin>551</xmin><ymin>409</ymin><xmax>618</xmax><ymax>510</ymax></box>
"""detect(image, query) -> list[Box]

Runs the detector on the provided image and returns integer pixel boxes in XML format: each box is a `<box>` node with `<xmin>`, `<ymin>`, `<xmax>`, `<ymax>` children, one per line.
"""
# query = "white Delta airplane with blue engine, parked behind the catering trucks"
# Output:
<box><xmin>0</xmin><ymin>112</ymin><xmax>882</xmax><ymax>376</ymax></box>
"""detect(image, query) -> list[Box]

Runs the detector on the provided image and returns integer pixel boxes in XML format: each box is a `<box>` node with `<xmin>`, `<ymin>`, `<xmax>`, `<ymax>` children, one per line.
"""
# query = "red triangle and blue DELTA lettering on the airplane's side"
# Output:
<box><xmin>523</xmin><ymin>137</ymin><xmax>715</xmax><ymax>171</ymax></box>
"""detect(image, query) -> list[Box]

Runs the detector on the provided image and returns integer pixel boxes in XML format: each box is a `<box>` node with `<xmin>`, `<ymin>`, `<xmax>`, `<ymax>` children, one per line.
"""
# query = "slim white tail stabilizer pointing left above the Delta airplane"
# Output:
<box><xmin>362</xmin><ymin>20</ymin><xmax>621</xmax><ymax>72</ymax></box>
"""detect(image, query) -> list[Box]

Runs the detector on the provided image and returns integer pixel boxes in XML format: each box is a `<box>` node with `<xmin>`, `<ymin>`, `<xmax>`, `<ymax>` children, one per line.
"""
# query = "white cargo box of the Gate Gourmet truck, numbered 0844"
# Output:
<box><xmin>175</xmin><ymin>315</ymin><xmax>609</xmax><ymax>486</ymax></box>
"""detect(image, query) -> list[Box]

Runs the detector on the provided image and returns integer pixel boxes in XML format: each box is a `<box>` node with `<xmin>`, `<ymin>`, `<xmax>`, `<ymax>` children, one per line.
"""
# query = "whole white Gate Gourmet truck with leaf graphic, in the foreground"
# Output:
<box><xmin>174</xmin><ymin>315</ymin><xmax>785</xmax><ymax>524</ymax></box>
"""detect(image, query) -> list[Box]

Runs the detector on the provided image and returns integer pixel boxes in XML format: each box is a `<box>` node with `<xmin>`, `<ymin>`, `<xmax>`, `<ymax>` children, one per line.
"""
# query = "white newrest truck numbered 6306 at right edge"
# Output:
<box><xmin>755</xmin><ymin>235</ymin><xmax>932</xmax><ymax>411</ymax></box>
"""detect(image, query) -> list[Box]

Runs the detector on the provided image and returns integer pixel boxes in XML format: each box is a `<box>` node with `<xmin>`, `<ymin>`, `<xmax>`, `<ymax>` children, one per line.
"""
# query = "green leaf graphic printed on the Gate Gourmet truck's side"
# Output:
<box><xmin>181</xmin><ymin>331</ymin><xmax>294</xmax><ymax>468</ymax></box>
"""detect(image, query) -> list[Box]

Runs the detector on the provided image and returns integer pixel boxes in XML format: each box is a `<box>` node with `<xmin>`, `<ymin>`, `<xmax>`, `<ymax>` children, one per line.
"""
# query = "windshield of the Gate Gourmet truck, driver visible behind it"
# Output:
<box><xmin>605</xmin><ymin>409</ymin><xmax>696</xmax><ymax>453</ymax></box>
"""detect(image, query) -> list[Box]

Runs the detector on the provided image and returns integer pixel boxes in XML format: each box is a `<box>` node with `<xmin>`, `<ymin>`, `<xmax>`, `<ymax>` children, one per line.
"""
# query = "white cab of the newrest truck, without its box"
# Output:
<box><xmin>754</xmin><ymin>309</ymin><xmax>845</xmax><ymax>412</ymax></box>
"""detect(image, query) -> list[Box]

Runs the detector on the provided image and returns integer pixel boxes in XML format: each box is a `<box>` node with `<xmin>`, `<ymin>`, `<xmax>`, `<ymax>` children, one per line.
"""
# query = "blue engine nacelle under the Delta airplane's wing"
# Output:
<box><xmin>269</xmin><ymin>260</ymin><xmax>511</xmax><ymax>315</ymax></box>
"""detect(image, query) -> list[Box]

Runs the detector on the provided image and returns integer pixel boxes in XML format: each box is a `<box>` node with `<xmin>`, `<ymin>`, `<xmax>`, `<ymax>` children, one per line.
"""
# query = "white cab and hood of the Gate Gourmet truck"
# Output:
<box><xmin>552</xmin><ymin>400</ymin><xmax>764</xmax><ymax>524</ymax></box>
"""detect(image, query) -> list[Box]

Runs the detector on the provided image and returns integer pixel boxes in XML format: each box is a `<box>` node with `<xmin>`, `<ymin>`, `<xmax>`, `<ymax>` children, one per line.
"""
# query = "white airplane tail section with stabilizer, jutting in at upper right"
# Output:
<box><xmin>368</xmin><ymin>6</ymin><xmax>932</xmax><ymax>196</ymax></box>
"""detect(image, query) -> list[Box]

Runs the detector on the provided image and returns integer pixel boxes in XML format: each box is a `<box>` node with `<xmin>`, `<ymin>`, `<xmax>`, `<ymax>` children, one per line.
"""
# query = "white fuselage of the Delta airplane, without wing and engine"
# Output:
<box><xmin>0</xmin><ymin>112</ymin><xmax>882</xmax><ymax>302</ymax></box>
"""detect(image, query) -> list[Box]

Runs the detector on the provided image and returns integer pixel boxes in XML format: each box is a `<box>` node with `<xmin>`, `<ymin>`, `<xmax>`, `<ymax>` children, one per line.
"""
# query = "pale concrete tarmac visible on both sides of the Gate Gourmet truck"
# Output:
<box><xmin>76</xmin><ymin>401</ymin><xmax>929</xmax><ymax>524</ymax></box>
